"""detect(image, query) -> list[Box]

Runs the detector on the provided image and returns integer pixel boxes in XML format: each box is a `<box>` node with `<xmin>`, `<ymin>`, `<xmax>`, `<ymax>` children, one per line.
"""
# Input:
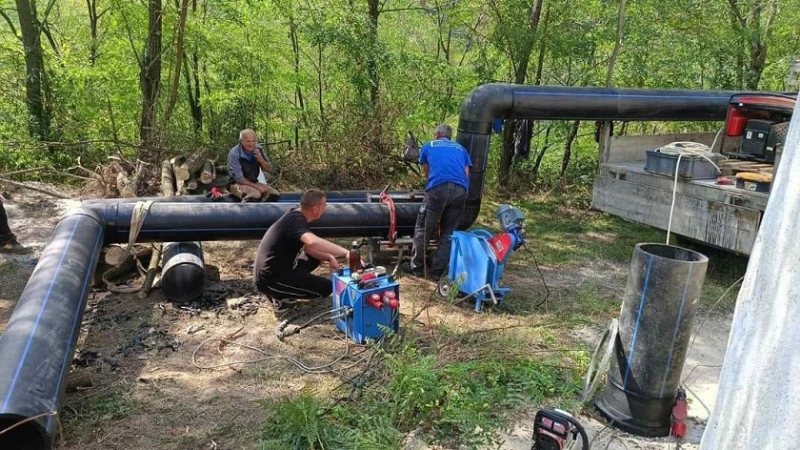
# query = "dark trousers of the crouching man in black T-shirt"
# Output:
<box><xmin>256</xmin><ymin>253</ymin><xmax>333</xmax><ymax>300</ymax></box>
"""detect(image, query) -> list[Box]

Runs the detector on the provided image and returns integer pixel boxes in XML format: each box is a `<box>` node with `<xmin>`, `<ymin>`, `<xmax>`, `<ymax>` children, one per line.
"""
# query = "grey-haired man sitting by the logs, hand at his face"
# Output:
<box><xmin>228</xmin><ymin>129</ymin><xmax>281</xmax><ymax>201</ymax></box>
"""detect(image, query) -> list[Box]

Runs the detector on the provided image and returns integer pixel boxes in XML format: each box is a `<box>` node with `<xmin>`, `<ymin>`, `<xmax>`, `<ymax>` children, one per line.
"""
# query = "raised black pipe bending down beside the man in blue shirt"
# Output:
<box><xmin>457</xmin><ymin>84</ymin><xmax>739</xmax><ymax>229</ymax></box>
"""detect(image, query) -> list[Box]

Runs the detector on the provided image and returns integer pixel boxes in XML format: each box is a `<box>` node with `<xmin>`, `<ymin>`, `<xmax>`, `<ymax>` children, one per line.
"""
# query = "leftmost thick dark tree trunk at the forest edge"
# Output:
<box><xmin>16</xmin><ymin>0</ymin><xmax>50</xmax><ymax>141</ymax></box>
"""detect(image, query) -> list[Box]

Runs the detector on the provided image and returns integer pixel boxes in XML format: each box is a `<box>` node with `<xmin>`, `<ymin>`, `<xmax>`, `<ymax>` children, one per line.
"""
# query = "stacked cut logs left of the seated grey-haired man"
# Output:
<box><xmin>161</xmin><ymin>151</ymin><xmax>228</xmax><ymax>196</ymax></box>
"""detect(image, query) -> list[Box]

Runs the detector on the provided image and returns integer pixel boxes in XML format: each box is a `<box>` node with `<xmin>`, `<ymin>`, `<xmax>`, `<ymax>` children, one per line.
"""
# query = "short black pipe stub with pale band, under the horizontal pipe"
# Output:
<box><xmin>161</xmin><ymin>242</ymin><xmax>206</xmax><ymax>303</ymax></box>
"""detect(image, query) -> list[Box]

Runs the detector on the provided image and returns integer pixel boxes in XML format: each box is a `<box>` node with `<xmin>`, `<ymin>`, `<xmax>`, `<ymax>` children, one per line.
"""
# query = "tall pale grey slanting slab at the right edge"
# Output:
<box><xmin>700</xmin><ymin>102</ymin><xmax>800</xmax><ymax>450</ymax></box>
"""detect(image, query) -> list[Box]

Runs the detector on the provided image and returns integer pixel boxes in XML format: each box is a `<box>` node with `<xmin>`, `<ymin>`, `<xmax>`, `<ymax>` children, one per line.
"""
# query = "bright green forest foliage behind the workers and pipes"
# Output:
<box><xmin>0</xmin><ymin>0</ymin><xmax>800</xmax><ymax>188</ymax></box>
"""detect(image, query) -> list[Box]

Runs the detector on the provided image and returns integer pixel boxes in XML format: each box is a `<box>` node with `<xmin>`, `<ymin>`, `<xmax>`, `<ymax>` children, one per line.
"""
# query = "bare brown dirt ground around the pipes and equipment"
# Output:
<box><xmin>0</xmin><ymin>185</ymin><xmax>731</xmax><ymax>450</ymax></box>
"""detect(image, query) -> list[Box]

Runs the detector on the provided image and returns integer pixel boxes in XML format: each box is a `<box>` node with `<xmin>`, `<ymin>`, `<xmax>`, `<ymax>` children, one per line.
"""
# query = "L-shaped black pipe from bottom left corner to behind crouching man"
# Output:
<box><xmin>0</xmin><ymin>202</ymin><xmax>419</xmax><ymax>450</ymax></box>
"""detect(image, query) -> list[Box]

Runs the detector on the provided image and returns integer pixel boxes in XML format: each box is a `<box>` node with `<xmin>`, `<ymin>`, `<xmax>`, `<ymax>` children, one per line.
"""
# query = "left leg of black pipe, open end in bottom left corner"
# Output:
<box><xmin>0</xmin><ymin>210</ymin><xmax>105</xmax><ymax>450</ymax></box>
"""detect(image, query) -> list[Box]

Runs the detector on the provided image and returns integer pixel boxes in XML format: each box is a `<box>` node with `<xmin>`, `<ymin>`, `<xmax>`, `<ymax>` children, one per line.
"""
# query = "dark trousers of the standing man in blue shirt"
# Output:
<box><xmin>411</xmin><ymin>182</ymin><xmax>467</xmax><ymax>276</ymax></box>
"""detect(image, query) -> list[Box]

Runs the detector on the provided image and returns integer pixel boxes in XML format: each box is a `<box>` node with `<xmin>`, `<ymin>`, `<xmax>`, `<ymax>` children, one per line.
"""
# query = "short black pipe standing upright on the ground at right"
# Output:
<box><xmin>595</xmin><ymin>244</ymin><xmax>708</xmax><ymax>437</ymax></box>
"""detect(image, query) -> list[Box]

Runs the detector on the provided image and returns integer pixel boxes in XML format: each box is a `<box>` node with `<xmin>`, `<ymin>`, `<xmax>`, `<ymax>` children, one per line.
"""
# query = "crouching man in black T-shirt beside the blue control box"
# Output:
<box><xmin>254</xmin><ymin>190</ymin><xmax>348</xmax><ymax>310</ymax></box>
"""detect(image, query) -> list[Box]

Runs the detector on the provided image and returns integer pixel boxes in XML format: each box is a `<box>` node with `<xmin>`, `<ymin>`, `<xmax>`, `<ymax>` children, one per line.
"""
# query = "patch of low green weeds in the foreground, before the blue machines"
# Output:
<box><xmin>261</xmin><ymin>345</ymin><xmax>578</xmax><ymax>449</ymax></box>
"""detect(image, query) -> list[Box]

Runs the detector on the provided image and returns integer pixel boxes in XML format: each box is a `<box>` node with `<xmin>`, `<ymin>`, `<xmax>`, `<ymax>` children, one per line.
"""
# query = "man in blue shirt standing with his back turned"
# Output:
<box><xmin>403</xmin><ymin>124</ymin><xmax>472</xmax><ymax>279</ymax></box>
